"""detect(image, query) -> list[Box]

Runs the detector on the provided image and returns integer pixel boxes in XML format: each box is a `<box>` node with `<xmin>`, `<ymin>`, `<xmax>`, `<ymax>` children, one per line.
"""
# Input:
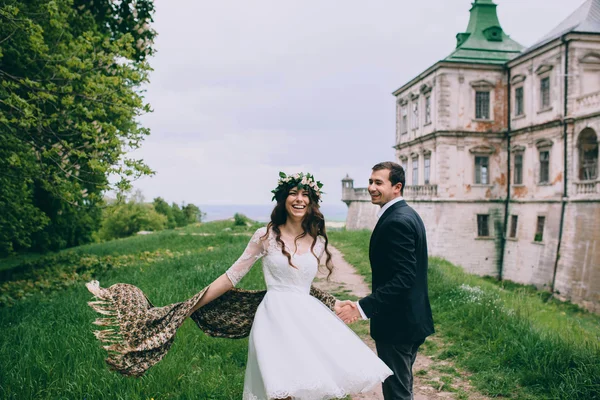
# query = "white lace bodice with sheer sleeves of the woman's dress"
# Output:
<box><xmin>226</xmin><ymin>227</ymin><xmax>325</xmax><ymax>293</ymax></box>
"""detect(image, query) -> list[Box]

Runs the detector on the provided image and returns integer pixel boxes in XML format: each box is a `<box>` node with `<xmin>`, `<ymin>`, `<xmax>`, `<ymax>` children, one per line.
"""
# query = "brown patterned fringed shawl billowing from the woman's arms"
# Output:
<box><xmin>86</xmin><ymin>281</ymin><xmax>335</xmax><ymax>377</ymax></box>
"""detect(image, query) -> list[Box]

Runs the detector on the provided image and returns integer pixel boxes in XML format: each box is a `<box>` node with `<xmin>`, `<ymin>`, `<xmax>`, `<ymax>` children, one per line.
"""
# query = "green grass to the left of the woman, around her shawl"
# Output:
<box><xmin>0</xmin><ymin>222</ymin><xmax>264</xmax><ymax>400</ymax></box>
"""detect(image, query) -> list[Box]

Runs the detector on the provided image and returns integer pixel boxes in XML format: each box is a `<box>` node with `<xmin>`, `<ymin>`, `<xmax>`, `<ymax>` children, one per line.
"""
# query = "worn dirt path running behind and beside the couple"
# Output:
<box><xmin>315</xmin><ymin>246</ymin><xmax>487</xmax><ymax>400</ymax></box>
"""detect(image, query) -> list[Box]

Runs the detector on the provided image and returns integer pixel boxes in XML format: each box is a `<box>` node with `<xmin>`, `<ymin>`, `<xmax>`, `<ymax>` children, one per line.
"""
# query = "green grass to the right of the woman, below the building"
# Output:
<box><xmin>330</xmin><ymin>231</ymin><xmax>600</xmax><ymax>400</ymax></box>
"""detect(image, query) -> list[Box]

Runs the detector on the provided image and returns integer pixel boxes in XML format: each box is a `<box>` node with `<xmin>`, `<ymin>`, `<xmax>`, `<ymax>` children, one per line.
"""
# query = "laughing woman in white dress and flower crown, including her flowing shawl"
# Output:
<box><xmin>86</xmin><ymin>173</ymin><xmax>392</xmax><ymax>400</ymax></box>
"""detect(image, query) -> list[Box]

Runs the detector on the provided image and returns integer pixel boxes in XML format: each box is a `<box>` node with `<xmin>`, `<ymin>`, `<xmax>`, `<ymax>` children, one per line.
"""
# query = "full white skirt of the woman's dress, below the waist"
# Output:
<box><xmin>243</xmin><ymin>288</ymin><xmax>392</xmax><ymax>400</ymax></box>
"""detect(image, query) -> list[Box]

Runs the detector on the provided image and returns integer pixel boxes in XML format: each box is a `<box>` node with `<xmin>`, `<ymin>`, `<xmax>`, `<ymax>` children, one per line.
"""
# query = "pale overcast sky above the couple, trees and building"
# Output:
<box><xmin>134</xmin><ymin>0</ymin><xmax>583</xmax><ymax>205</ymax></box>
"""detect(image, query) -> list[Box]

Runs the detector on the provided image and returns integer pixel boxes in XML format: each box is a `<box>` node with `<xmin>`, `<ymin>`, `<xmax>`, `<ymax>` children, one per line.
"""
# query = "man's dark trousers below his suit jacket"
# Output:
<box><xmin>375</xmin><ymin>340</ymin><xmax>424</xmax><ymax>400</ymax></box>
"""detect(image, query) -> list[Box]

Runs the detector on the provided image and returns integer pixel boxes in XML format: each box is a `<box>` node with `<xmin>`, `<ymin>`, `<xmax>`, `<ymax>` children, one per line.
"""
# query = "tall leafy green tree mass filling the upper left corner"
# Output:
<box><xmin>0</xmin><ymin>0</ymin><xmax>156</xmax><ymax>254</ymax></box>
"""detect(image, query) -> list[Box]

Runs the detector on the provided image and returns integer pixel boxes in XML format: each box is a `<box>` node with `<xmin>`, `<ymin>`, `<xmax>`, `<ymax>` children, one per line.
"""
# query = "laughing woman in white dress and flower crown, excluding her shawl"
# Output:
<box><xmin>193</xmin><ymin>173</ymin><xmax>392</xmax><ymax>400</ymax></box>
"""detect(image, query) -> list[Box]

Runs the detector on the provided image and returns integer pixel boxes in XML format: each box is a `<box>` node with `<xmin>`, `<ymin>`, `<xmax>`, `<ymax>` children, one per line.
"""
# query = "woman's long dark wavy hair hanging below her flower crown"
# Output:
<box><xmin>263</xmin><ymin>187</ymin><xmax>333</xmax><ymax>279</ymax></box>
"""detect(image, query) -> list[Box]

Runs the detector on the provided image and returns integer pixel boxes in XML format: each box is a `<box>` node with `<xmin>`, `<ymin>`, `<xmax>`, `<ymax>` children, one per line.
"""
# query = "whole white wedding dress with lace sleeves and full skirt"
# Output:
<box><xmin>227</xmin><ymin>228</ymin><xmax>392</xmax><ymax>400</ymax></box>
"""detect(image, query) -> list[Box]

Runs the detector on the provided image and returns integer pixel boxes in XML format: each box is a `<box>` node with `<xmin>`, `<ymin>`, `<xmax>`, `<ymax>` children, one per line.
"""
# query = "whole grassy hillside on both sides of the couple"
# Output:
<box><xmin>0</xmin><ymin>222</ymin><xmax>600</xmax><ymax>400</ymax></box>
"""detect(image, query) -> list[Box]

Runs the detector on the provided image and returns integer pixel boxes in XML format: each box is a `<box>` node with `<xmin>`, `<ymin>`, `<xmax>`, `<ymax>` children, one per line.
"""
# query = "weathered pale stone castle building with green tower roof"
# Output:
<box><xmin>342</xmin><ymin>0</ymin><xmax>600</xmax><ymax>311</ymax></box>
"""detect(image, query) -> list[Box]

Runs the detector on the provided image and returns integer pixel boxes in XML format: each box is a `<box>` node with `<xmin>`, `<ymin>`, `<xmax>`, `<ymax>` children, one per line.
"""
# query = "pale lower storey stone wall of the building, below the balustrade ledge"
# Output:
<box><xmin>347</xmin><ymin>200</ymin><xmax>600</xmax><ymax>312</ymax></box>
